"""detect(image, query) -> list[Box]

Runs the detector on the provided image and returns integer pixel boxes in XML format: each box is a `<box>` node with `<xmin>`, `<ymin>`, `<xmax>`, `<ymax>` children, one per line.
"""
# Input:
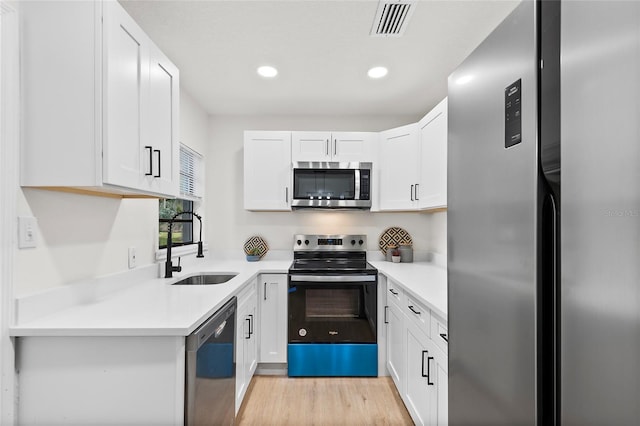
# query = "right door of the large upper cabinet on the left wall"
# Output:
<box><xmin>143</xmin><ymin>44</ymin><xmax>180</xmax><ymax>194</ymax></box>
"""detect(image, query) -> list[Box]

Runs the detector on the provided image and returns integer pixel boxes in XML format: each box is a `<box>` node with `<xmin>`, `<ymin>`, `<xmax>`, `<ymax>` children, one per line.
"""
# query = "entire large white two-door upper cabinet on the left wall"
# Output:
<box><xmin>21</xmin><ymin>1</ymin><xmax>179</xmax><ymax>197</ymax></box>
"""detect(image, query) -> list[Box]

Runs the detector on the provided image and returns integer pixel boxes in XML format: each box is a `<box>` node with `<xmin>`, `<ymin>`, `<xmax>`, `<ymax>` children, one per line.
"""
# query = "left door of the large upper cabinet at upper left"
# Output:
<box><xmin>103</xmin><ymin>2</ymin><xmax>150</xmax><ymax>189</ymax></box>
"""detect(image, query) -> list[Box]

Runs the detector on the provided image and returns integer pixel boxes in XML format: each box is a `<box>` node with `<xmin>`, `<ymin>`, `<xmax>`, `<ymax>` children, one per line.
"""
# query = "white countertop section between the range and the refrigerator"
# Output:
<box><xmin>369</xmin><ymin>261</ymin><xmax>447</xmax><ymax>320</ymax></box>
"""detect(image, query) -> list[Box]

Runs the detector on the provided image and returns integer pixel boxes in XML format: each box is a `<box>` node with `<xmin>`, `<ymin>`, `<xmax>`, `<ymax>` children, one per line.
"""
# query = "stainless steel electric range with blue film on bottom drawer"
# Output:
<box><xmin>287</xmin><ymin>235</ymin><xmax>378</xmax><ymax>376</ymax></box>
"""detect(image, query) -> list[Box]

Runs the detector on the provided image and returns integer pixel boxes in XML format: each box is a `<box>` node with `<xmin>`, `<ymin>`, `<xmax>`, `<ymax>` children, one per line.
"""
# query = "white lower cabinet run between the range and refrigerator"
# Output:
<box><xmin>385</xmin><ymin>277</ymin><xmax>448</xmax><ymax>426</ymax></box>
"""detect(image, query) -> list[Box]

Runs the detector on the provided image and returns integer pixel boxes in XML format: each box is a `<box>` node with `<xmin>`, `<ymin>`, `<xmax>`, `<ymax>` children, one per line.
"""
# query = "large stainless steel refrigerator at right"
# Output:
<box><xmin>448</xmin><ymin>0</ymin><xmax>640</xmax><ymax>426</ymax></box>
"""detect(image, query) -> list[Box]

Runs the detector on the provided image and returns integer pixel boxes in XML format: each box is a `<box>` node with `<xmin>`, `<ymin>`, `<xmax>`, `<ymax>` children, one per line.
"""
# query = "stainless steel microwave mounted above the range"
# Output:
<box><xmin>291</xmin><ymin>161</ymin><xmax>372</xmax><ymax>210</ymax></box>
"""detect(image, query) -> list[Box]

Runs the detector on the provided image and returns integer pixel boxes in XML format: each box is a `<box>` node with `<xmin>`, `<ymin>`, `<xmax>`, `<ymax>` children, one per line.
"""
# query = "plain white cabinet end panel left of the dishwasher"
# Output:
<box><xmin>15</xmin><ymin>336</ymin><xmax>185</xmax><ymax>425</ymax></box>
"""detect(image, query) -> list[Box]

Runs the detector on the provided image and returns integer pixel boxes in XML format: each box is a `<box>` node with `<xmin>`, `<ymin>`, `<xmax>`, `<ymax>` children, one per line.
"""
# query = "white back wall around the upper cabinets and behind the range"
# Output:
<box><xmin>206</xmin><ymin>116</ymin><xmax>446</xmax><ymax>255</ymax></box>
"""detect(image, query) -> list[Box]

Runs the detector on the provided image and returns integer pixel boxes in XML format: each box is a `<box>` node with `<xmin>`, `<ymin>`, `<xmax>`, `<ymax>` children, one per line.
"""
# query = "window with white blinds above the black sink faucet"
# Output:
<box><xmin>159</xmin><ymin>144</ymin><xmax>204</xmax><ymax>249</ymax></box>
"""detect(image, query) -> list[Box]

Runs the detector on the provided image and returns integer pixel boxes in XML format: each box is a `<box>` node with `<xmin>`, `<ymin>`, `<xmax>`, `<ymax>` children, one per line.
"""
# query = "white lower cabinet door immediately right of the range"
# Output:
<box><xmin>387</xmin><ymin>303</ymin><xmax>405</xmax><ymax>395</ymax></box>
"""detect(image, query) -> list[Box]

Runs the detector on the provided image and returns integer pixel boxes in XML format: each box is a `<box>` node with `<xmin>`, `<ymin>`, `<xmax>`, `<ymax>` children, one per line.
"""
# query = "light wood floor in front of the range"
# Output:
<box><xmin>236</xmin><ymin>376</ymin><xmax>413</xmax><ymax>426</ymax></box>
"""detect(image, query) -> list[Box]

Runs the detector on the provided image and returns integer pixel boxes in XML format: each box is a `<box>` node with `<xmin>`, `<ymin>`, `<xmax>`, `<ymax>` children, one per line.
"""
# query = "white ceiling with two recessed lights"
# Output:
<box><xmin>120</xmin><ymin>0</ymin><xmax>519</xmax><ymax>116</ymax></box>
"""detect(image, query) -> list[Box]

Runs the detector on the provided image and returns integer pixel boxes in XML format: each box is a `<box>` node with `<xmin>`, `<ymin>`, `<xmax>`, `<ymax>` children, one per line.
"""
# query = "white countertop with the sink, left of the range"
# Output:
<box><xmin>9</xmin><ymin>260</ymin><xmax>291</xmax><ymax>336</ymax></box>
